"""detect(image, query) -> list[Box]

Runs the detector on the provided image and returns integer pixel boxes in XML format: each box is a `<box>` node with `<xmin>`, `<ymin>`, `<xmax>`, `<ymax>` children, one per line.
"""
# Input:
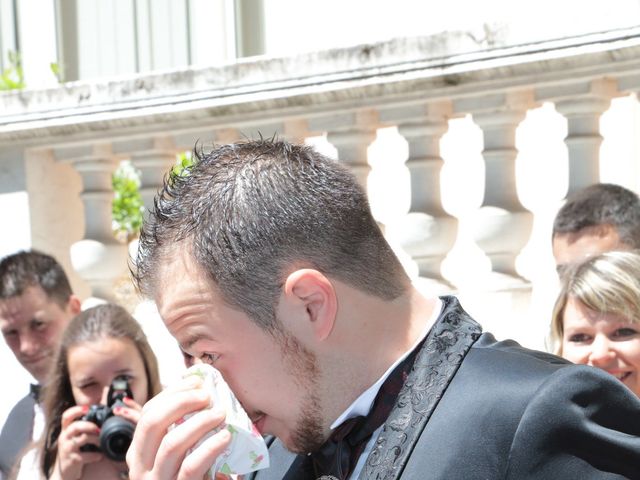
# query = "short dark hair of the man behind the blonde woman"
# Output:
<box><xmin>552</xmin><ymin>183</ymin><xmax>640</xmax><ymax>249</ymax></box>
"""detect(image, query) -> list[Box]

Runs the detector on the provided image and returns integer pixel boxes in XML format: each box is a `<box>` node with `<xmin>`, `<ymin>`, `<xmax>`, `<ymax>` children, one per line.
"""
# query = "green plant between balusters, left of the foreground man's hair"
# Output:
<box><xmin>111</xmin><ymin>161</ymin><xmax>144</xmax><ymax>242</ymax></box>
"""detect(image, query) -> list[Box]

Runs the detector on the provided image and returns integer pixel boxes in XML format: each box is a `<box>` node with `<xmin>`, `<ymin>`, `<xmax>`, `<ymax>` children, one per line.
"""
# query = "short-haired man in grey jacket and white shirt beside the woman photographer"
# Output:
<box><xmin>0</xmin><ymin>250</ymin><xmax>80</xmax><ymax>478</ymax></box>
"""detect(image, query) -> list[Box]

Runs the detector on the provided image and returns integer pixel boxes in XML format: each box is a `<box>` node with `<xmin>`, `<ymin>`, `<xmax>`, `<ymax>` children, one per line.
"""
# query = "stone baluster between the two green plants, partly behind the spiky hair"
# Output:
<box><xmin>113</xmin><ymin>137</ymin><xmax>176</xmax><ymax>211</ymax></box>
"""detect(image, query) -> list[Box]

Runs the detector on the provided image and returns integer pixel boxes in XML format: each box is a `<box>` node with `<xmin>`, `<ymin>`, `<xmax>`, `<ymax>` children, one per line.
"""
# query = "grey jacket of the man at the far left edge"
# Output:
<box><xmin>0</xmin><ymin>395</ymin><xmax>36</xmax><ymax>478</ymax></box>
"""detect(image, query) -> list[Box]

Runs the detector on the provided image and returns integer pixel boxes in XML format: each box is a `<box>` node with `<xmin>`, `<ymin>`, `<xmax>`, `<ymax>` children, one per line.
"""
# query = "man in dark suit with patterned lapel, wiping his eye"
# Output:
<box><xmin>127</xmin><ymin>140</ymin><xmax>640</xmax><ymax>480</ymax></box>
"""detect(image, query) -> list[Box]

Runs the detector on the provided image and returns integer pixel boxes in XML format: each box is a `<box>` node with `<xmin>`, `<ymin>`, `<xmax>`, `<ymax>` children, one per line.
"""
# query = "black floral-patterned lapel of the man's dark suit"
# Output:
<box><xmin>358</xmin><ymin>296</ymin><xmax>482</xmax><ymax>480</ymax></box>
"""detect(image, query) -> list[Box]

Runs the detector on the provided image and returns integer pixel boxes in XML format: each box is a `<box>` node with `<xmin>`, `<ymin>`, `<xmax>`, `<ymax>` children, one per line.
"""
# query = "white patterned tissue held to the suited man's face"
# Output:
<box><xmin>176</xmin><ymin>364</ymin><xmax>269</xmax><ymax>478</ymax></box>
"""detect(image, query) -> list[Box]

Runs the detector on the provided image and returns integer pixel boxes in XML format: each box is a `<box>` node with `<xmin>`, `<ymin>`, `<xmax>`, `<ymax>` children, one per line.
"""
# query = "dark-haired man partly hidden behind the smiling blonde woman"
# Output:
<box><xmin>552</xmin><ymin>183</ymin><xmax>640</xmax><ymax>275</ymax></box>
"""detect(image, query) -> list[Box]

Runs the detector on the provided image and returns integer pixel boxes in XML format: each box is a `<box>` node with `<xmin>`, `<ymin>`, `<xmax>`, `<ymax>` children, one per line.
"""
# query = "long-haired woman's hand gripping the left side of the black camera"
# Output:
<box><xmin>52</xmin><ymin>405</ymin><xmax>102</xmax><ymax>480</ymax></box>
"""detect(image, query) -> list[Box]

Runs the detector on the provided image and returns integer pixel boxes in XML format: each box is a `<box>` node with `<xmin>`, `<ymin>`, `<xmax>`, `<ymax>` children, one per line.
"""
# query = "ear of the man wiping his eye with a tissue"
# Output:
<box><xmin>284</xmin><ymin>268</ymin><xmax>338</xmax><ymax>340</ymax></box>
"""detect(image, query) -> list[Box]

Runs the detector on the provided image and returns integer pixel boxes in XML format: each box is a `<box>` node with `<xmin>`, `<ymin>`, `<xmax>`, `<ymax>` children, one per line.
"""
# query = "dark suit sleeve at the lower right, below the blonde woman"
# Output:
<box><xmin>506</xmin><ymin>366</ymin><xmax>640</xmax><ymax>480</ymax></box>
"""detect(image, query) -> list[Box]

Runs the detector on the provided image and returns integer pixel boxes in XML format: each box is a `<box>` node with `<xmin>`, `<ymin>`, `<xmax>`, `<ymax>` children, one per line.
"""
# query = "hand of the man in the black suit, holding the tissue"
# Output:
<box><xmin>127</xmin><ymin>375</ymin><xmax>231</xmax><ymax>480</ymax></box>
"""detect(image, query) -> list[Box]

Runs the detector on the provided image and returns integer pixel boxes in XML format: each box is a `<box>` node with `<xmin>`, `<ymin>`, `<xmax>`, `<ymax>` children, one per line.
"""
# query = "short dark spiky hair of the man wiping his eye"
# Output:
<box><xmin>132</xmin><ymin>139</ymin><xmax>409</xmax><ymax>330</ymax></box>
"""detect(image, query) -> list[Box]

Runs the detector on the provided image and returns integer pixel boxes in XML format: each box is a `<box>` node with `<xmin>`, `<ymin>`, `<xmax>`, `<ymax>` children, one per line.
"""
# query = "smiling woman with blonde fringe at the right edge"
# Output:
<box><xmin>551</xmin><ymin>251</ymin><xmax>640</xmax><ymax>397</ymax></box>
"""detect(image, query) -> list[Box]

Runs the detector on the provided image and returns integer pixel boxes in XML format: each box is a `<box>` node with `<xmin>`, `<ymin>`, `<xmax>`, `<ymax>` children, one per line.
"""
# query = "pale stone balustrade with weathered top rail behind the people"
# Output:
<box><xmin>0</xmin><ymin>28</ymin><xmax>640</xmax><ymax>346</ymax></box>
